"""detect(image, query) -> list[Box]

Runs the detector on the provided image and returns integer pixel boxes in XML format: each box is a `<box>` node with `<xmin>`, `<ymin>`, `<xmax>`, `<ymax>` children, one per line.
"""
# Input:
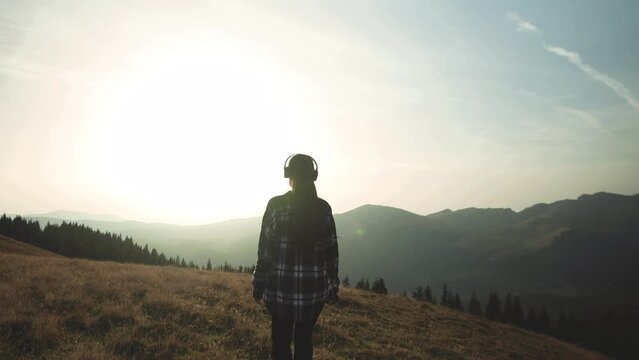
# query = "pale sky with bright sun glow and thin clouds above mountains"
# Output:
<box><xmin>0</xmin><ymin>0</ymin><xmax>639</xmax><ymax>224</ymax></box>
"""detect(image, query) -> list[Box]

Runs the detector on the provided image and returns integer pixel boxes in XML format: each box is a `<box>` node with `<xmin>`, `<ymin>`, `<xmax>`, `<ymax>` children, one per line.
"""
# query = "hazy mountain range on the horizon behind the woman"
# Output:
<box><xmin>21</xmin><ymin>192</ymin><xmax>639</xmax><ymax>310</ymax></box>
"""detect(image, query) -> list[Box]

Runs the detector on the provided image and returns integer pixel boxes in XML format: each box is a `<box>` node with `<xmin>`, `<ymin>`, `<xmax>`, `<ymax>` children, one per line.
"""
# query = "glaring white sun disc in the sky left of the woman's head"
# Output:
<box><xmin>86</xmin><ymin>31</ymin><xmax>320</xmax><ymax>220</ymax></box>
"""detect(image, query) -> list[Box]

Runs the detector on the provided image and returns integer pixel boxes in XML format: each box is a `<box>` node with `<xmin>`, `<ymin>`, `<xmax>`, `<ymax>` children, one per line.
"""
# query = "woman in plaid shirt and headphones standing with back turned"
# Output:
<box><xmin>253</xmin><ymin>154</ymin><xmax>339</xmax><ymax>360</ymax></box>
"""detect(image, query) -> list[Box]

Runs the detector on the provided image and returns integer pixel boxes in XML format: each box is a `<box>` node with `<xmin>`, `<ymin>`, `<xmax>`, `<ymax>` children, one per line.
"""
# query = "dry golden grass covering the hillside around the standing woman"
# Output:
<box><xmin>0</xmin><ymin>238</ymin><xmax>603</xmax><ymax>359</ymax></box>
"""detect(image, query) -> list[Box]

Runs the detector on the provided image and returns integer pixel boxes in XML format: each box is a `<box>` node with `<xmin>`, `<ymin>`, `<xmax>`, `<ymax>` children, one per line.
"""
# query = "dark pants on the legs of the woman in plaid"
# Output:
<box><xmin>271</xmin><ymin>314</ymin><xmax>319</xmax><ymax>360</ymax></box>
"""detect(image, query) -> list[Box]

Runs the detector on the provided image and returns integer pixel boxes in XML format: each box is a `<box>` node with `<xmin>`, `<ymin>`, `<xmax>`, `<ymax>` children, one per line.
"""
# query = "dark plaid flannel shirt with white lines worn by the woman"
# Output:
<box><xmin>253</xmin><ymin>191</ymin><xmax>339</xmax><ymax>321</ymax></box>
